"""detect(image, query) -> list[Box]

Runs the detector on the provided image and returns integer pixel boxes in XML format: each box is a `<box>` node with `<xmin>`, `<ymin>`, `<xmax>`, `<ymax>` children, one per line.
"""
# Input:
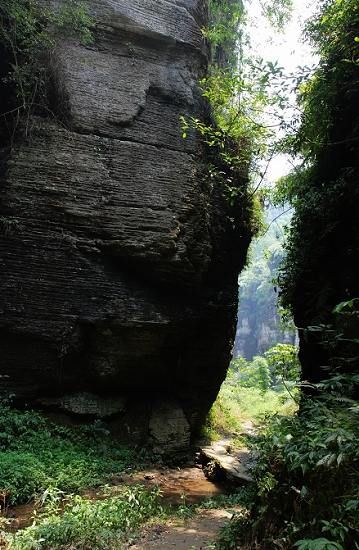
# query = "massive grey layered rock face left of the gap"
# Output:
<box><xmin>0</xmin><ymin>0</ymin><xmax>250</xmax><ymax>452</ymax></box>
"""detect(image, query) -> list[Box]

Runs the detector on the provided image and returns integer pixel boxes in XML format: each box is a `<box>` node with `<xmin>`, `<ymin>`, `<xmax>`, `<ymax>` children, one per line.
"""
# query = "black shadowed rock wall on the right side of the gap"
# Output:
<box><xmin>285</xmin><ymin>25</ymin><xmax>359</xmax><ymax>383</ymax></box>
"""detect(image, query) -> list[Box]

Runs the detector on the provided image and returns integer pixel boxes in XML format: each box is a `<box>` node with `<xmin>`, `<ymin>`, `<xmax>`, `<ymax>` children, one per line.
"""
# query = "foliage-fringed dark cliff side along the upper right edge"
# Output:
<box><xmin>278</xmin><ymin>0</ymin><xmax>359</xmax><ymax>316</ymax></box>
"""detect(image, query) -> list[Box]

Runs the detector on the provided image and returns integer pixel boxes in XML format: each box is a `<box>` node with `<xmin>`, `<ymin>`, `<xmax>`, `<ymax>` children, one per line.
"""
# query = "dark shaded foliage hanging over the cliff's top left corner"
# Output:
<box><xmin>0</xmin><ymin>0</ymin><xmax>94</xmax><ymax>138</ymax></box>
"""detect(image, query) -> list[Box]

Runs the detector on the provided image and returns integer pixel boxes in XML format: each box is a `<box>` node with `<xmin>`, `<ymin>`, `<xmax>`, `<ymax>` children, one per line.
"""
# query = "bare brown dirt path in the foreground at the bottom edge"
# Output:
<box><xmin>127</xmin><ymin>508</ymin><xmax>239</xmax><ymax>550</ymax></box>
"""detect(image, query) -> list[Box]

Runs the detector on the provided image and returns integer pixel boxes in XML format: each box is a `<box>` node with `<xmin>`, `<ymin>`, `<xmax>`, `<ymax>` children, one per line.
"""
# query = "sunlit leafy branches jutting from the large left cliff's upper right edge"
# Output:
<box><xmin>188</xmin><ymin>58</ymin><xmax>281</xmax><ymax>190</ymax></box>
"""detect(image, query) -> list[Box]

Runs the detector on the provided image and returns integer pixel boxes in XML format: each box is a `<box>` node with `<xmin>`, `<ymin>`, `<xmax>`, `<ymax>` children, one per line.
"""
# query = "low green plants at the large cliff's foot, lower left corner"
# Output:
<box><xmin>0</xmin><ymin>404</ymin><xmax>162</xmax><ymax>550</ymax></box>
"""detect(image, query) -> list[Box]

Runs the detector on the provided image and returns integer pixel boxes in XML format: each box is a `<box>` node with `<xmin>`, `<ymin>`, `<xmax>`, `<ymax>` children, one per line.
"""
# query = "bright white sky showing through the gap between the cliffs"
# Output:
<box><xmin>247</xmin><ymin>0</ymin><xmax>318</xmax><ymax>184</ymax></box>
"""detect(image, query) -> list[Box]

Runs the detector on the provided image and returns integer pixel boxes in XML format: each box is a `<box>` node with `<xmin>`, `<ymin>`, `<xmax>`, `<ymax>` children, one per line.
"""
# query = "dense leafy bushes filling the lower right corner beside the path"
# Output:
<box><xmin>221</xmin><ymin>316</ymin><xmax>359</xmax><ymax>550</ymax></box>
